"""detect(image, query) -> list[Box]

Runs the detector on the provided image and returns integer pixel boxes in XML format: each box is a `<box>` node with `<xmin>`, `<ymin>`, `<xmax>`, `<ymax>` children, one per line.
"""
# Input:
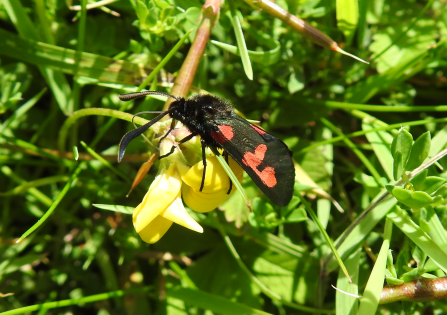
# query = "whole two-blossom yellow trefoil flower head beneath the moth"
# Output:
<box><xmin>133</xmin><ymin>133</ymin><xmax>243</xmax><ymax>244</ymax></box>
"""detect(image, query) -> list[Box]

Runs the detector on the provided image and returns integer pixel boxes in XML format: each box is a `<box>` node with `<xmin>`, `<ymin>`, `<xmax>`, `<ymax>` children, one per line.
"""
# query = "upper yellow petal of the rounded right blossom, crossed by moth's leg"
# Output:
<box><xmin>183</xmin><ymin>156</ymin><xmax>243</xmax><ymax>193</ymax></box>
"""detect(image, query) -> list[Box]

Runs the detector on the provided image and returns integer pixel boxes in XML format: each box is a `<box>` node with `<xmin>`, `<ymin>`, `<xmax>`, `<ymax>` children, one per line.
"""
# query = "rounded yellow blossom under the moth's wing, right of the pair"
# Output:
<box><xmin>182</xmin><ymin>156</ymin><xmax>243</xmax><ymax>212</ymax></box>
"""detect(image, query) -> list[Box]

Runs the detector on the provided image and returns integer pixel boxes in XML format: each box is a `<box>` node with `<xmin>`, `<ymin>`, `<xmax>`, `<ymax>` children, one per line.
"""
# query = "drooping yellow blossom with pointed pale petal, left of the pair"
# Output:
<box><xmin>133</xmin><ymin>160</ymin><xmax>203</xmax><ymax>244</ymax></box>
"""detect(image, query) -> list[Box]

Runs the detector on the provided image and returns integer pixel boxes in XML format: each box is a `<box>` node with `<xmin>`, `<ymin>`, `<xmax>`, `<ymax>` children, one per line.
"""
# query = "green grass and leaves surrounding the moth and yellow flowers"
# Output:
<box><xmin>0</xmin><ymin>0</ymin><xmax>447</xmax><ymax>315</ymax></box>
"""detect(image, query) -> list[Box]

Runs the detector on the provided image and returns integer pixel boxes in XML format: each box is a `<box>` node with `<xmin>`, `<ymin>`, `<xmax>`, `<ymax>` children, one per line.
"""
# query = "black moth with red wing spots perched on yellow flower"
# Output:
<box><xmin>118</xmin><ymin>91</ymin><xmax>295</xmax><ymax>206</ymax></box>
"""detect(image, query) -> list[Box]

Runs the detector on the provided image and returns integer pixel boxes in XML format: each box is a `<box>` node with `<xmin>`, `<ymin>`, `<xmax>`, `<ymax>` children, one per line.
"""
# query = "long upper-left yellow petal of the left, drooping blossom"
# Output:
<box><xmin>133</xmin><ymin>163</ymin><xmax>182</xmax><ymax>233</ymax></box>
